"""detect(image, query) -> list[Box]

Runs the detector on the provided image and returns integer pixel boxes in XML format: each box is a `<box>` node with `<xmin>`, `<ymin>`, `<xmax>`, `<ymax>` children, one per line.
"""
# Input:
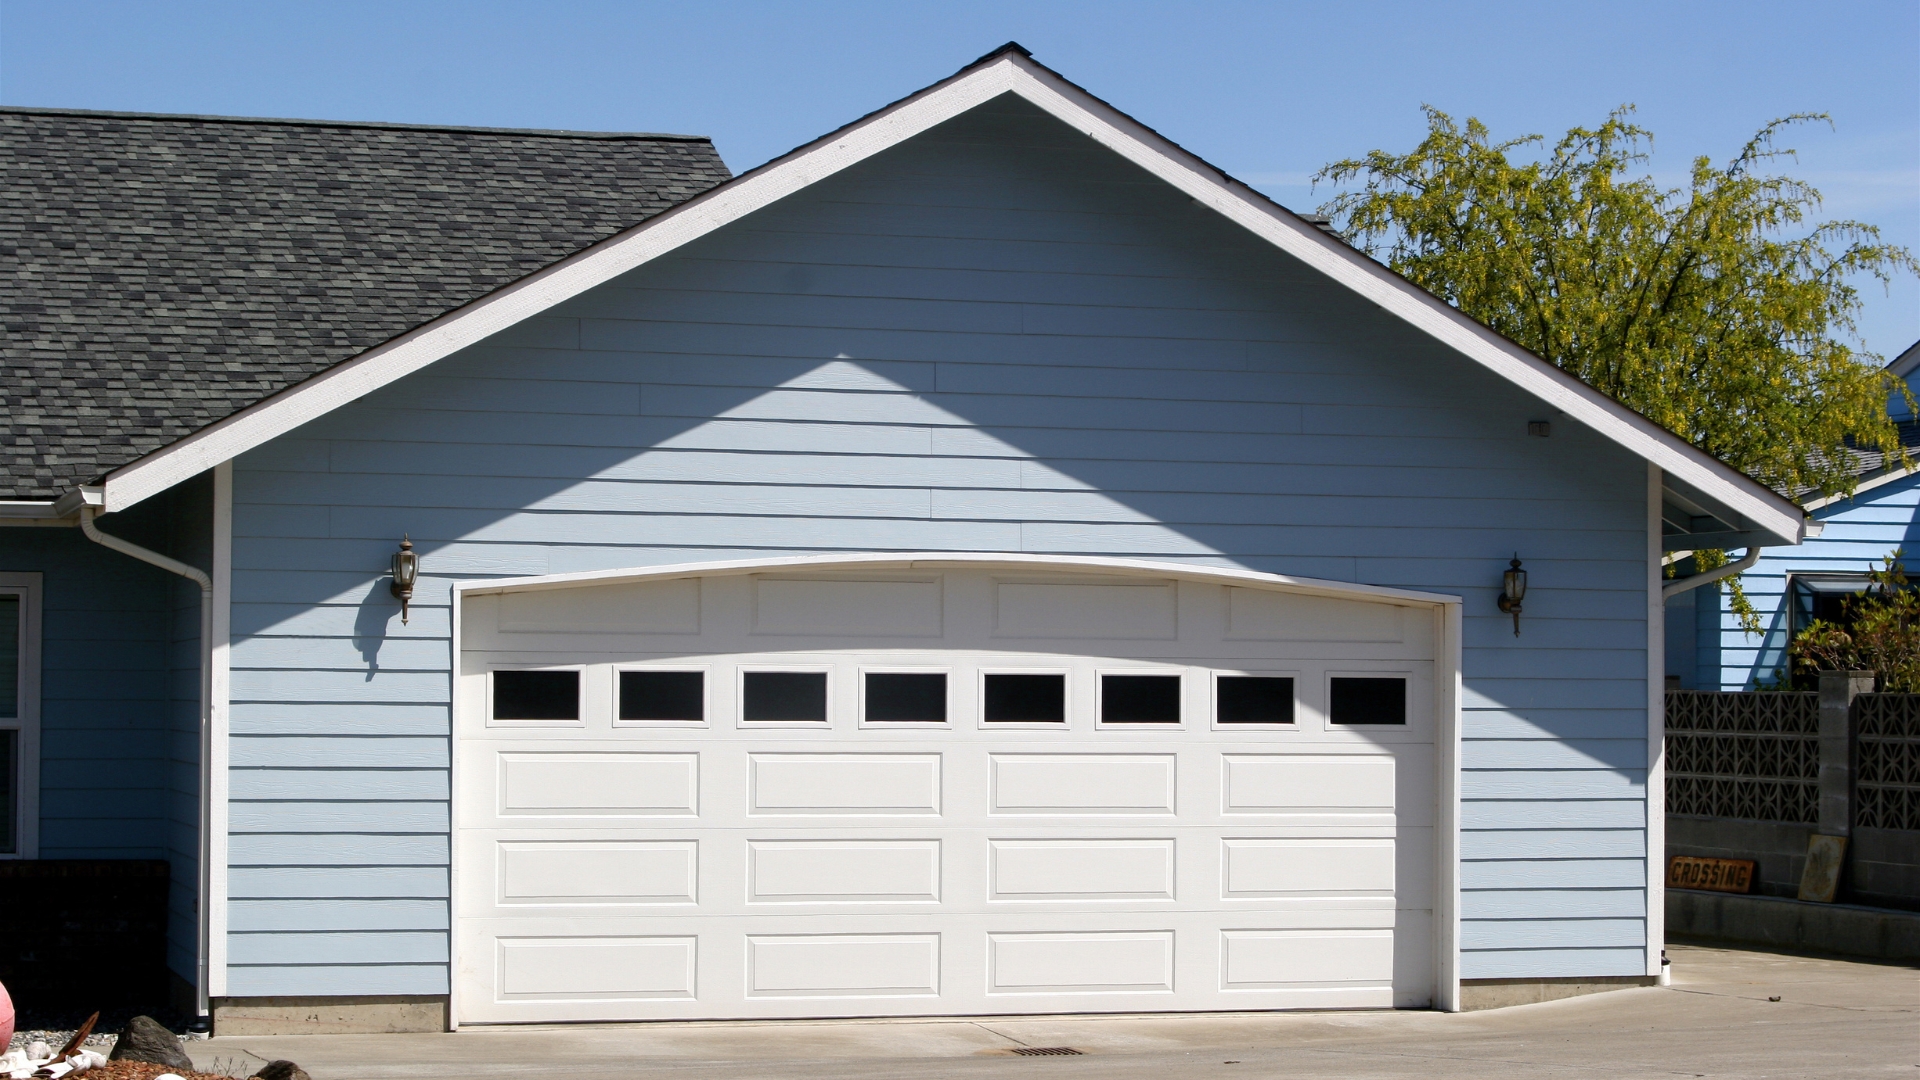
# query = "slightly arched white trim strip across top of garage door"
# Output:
<box><xmin>453</xmin><ymin>552</ymin><xmax>1463</xmax><ymax>605</ymax></box>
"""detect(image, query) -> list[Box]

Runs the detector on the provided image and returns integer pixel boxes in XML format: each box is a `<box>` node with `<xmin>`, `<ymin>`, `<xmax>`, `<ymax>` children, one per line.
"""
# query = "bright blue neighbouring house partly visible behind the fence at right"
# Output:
<box><xmin>1667</xmin><ymin>344</ymin><xmax>1920</xmax><ymax>690</ymax></box>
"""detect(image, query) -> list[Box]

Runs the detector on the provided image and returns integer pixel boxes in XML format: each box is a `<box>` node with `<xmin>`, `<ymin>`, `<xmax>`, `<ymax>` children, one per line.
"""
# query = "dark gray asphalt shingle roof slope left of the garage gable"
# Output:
<box><xmin>0</xmin><ymin>108</ymin><xmax>728</xmax><ymax>500</ymax></box>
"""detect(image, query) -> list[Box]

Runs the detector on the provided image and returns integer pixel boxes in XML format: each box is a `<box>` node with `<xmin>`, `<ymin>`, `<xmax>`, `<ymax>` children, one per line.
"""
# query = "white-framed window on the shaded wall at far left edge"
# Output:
<box><xmin>0</xmin><ymin>573</ymin><xmax>40</xmax><ymax>859</ymax></box>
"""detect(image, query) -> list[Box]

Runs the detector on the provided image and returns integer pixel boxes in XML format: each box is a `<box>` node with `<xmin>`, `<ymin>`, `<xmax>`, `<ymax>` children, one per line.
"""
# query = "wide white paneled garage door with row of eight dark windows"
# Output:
<box><xmin>455</xmin><ymin>563</ymin><xmax>1434</xmax><ymax>1022</ymax></box>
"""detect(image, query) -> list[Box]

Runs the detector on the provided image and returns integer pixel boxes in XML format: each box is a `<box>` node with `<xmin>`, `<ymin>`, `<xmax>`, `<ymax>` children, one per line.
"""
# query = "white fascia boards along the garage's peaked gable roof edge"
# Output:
<box><xmin>90</xmin><ymin>46</ymin><xmax>1803</xmax><ymax>544</ymax></box>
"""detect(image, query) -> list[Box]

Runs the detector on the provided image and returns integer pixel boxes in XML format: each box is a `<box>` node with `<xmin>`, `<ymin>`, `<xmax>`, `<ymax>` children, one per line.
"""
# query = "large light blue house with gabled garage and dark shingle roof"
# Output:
<box><xmin>0</xmin><ymin>46</ymin><xmax>1803</xmax><ymax>1030</ymax></box>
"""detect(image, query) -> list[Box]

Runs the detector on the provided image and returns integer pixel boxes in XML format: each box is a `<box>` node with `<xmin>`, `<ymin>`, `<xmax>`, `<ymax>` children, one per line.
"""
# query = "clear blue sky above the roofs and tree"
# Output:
<box><xmin>0</xmin><ymin>0</ymin><xmax>1920</xmax><ymax>357</ymax></box>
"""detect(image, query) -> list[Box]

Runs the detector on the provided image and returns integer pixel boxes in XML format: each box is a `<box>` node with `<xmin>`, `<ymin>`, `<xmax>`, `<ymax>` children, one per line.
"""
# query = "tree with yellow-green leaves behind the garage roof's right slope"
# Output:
<box><xmin>1315</xmin><ymin>106</ymin><xmax>1920</xmax><ymax>613</ymax></box>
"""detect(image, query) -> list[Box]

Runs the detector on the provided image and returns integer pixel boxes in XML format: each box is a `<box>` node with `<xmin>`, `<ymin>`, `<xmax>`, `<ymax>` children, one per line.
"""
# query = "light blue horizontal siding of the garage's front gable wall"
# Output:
<box><xmin>228</xmin><ymin>98</ymin><xmax>1647</xmax><ymax>995</ymax></box>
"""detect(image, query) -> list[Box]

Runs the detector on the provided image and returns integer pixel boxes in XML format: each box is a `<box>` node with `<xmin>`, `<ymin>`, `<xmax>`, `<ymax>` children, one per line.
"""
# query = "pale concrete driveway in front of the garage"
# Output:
<box><xmin>188</xmin><ymin>945</ymin><xmax>1920</xmax><ymax>1080</ymax></box>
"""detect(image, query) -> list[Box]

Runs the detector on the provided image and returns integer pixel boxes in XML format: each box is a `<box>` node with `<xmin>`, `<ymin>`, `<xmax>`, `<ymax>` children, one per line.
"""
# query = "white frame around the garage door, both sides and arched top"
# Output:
<box><xmin>447</xmin><ymin>552</ymin><xmax>1463</xmax><ymax>1030</ymax></box>
